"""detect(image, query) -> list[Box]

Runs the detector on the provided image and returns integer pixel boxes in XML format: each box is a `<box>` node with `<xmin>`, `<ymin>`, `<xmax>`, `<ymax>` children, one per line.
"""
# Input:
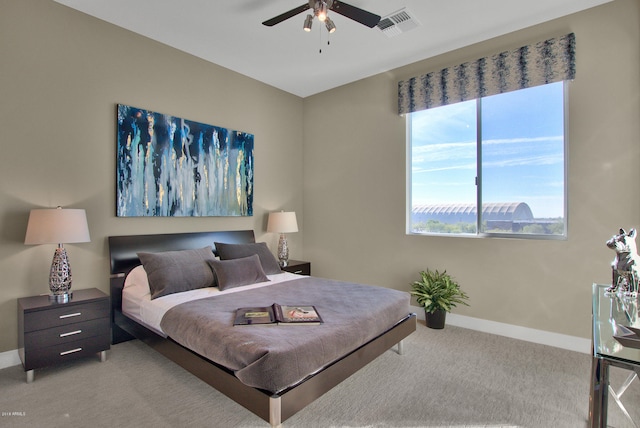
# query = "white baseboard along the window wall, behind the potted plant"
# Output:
<box><xmin>413</xmin><ymin>306</ymin><xmax>591</xmax><ymax>355</ymax></box>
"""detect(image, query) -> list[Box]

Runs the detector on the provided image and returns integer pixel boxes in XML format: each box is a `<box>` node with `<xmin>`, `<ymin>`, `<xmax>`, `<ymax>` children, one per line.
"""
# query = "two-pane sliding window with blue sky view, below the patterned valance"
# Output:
<box><xmin>407</xmin><ymin>81</ymin><xmax>567</xmax><ymax>239</ymax></box>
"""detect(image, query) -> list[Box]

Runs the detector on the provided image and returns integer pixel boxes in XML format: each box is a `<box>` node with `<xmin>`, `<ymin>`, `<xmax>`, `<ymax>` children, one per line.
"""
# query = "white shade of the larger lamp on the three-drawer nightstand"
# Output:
<box><xmin>24</xmin><ymin>208</ymin><xmax>91</xmax><ymax>245</ymax></box>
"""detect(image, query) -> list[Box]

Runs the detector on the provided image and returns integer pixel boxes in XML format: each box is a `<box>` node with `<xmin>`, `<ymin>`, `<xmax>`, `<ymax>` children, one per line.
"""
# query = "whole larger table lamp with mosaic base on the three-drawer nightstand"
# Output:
<box><xmin>24</xmin><ymin>207</ymin><xmax>91</xmax><ymax>303</ymax></box>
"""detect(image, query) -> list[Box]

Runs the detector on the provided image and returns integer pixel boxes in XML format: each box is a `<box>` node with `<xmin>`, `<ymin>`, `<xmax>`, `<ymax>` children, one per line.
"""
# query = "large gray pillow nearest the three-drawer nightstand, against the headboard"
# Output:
<box><xmin>138</xmin><ymin>247</ymin><xmax>215</xmax><ymax>300</ymax></box>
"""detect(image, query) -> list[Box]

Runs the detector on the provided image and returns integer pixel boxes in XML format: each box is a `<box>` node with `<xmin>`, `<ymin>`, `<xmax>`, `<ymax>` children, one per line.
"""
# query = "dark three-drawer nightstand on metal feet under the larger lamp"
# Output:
<box><xmin>18</xmin><ymin>288</ymin><xmax>111</xmax><ymax>382</ymax></box>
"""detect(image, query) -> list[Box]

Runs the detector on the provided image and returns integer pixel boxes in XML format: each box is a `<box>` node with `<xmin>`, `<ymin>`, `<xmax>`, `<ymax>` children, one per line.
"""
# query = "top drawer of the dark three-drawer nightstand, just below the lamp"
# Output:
<box><xmin>24</xmin><ymin>299</ymin><xmax>109</xmax><ymax>333</ymax></box>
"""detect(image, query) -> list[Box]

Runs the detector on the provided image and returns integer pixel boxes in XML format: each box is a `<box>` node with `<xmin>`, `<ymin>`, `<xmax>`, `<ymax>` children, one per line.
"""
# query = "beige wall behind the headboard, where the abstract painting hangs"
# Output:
<box><xmin>0</xmin><ymin>0</ymin><xmax>304</xmax><ymax>352</ymax></box>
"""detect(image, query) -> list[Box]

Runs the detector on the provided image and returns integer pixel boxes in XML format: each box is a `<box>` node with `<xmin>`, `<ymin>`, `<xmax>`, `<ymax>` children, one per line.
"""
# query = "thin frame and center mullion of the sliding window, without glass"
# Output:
<box><xmin>405</xmin><ymin>80</ymin><xmax>571</xmax><ymax>241</ymax></box>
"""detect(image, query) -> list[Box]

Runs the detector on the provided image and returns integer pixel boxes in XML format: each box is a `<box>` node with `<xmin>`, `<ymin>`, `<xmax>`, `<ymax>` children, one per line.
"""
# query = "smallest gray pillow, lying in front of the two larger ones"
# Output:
<box><xmin>208</xmin><ymin>254</ymin><xmax>269</xmax><ymax>291</ymax></box>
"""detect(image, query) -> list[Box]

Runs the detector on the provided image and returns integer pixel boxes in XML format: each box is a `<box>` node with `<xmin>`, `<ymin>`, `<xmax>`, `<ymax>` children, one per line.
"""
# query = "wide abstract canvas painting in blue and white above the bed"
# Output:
<box><xmin>117</xmin><ymin>104</ymin><xmax>253</xmax><ymax>217</ymax></box>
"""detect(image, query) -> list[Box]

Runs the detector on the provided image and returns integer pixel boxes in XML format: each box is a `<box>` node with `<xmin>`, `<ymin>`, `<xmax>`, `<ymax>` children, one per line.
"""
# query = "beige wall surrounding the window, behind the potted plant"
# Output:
<box><xmin>304</xmin><ymin>0</ymin><xmax>640</xmax><ymax>338</ymax></box>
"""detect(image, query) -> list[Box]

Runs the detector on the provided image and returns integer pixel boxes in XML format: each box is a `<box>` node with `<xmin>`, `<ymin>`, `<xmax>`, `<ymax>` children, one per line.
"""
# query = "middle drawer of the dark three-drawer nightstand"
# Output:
<box><xmin>24</xmin><ymin>318</ymin><xmax>109</xmax><ymax>350</ymax></box>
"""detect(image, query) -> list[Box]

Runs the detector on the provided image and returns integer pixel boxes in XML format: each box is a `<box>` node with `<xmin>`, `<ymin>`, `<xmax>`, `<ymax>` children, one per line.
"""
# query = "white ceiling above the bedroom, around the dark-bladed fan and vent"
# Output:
<box><xmin>55</xmin><ymin>0</ymin><xmax>611</xmax><ymax>97</ymax></box>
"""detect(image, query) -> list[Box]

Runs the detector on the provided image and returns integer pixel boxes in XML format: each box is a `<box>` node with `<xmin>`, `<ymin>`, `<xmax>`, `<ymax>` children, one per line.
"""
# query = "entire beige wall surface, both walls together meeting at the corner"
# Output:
<box><xmin>0</xmin><ymin>0</ymin><xmax>640</xmax><ymax>352</ymax></box>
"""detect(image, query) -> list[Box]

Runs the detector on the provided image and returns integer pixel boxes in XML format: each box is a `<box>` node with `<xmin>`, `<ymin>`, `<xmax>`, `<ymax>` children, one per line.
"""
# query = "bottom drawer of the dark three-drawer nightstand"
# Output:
<box><xmin>24</xmin><ymin>335</ymin><xmax>109</xmax><ymax>370</ymax></box>
